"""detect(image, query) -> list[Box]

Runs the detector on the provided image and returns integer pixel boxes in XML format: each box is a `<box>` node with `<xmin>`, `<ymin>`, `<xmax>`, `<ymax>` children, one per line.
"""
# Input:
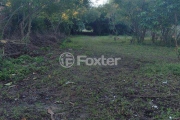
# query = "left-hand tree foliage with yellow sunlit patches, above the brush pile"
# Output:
<box><xmin>2</xmin><ymin>0</ymin><xmax>89</xmax><ymax>39</ymax></box>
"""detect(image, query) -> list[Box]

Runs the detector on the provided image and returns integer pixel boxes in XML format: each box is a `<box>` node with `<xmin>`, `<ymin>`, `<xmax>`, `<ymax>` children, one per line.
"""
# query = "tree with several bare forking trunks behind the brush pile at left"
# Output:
<box><xmin>3</xmin><ymin>0</ymin><xmax>48</xmax><ymax>42</ymax></box>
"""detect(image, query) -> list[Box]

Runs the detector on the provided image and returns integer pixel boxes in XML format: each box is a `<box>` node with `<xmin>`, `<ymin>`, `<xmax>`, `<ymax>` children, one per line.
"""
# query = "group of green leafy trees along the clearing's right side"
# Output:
<box><xmin>114</xmin><ymin>0</ymin><xmax>180</xmax><ymax>46</ymax></box>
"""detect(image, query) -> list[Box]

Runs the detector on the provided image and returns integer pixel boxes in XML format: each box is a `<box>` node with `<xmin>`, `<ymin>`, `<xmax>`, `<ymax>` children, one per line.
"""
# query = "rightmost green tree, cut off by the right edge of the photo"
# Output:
<box><xmin>146</xmin><ymin>0</ymin><xmax>180</xmax><ymax>46</ymax></box>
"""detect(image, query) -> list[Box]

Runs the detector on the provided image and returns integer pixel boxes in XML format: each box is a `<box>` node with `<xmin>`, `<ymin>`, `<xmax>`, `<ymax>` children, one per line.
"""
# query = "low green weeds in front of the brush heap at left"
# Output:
<box><xmin>0</xmin><ymin>55</ymin><xmax>44</xmax><ymax>81</ymax></box>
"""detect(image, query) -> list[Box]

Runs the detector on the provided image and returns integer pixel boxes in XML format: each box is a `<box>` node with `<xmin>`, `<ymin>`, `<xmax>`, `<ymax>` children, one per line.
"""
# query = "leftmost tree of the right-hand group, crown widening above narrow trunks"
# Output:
<box><xmin>114</xmin><ymin>0</ymin><xmax>152</xmax><ymax>43</ymax></box>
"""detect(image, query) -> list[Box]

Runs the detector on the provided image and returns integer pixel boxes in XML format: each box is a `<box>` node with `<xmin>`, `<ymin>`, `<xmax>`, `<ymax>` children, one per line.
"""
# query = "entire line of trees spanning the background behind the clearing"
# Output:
<box><xmin>0</xmin><ymin>0</ymin><xmax>180</xmax><ymax>46</ymax></box>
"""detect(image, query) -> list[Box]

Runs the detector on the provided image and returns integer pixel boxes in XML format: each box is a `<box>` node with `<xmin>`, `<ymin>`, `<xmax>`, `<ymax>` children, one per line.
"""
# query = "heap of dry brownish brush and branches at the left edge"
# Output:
<box><xmin>0</xmin><ymin>33</ymin><xmax>65</xmax><ymax>58</ymax></box>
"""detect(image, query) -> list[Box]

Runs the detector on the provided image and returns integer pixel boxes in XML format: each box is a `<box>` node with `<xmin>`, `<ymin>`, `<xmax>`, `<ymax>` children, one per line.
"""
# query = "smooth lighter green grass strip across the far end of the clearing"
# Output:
<box><xmin>68</xmin><ymin>36</ymin><xmax>177</xmax><ymax>61</ymax></box>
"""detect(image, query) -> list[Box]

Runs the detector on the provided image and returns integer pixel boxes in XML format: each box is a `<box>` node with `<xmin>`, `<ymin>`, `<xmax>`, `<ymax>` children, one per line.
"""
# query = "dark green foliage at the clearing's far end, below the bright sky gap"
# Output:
<box><xmin>85</xmin><ymin>4</ymin><xmax>129</xmax><ymax>35</ymax></box>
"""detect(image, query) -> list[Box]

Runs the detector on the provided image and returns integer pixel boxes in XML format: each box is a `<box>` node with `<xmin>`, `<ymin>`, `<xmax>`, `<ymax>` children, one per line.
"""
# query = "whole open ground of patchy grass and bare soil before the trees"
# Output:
<box><xmin>0</xmin><ymin>36</ymin><xmax>180</xmax><ymax>120</ymax></box>
